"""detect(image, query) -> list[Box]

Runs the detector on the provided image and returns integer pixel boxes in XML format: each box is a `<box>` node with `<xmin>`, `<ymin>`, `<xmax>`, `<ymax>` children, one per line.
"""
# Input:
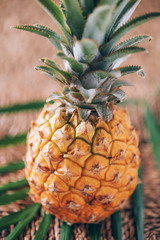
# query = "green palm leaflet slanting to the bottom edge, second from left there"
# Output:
<box><xmin>34</xmin><ymin>212</ymin><xmax>52</xmax><ymax>240</ymax></box>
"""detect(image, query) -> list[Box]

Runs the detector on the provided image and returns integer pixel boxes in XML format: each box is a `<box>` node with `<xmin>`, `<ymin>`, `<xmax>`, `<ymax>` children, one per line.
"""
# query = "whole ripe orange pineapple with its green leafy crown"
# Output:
<box><xmin>16</xmin><ymin>0</ymin><xmax>160</xmax><ymax>224</ymax></box>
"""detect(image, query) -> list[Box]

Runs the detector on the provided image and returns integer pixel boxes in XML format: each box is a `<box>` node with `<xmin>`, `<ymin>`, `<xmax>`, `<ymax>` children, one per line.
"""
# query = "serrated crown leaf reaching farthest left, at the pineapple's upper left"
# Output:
<box><xmin>14</xmin><ymin>24</ymin><xmax>65</xmax><ymax>50</ymax></box>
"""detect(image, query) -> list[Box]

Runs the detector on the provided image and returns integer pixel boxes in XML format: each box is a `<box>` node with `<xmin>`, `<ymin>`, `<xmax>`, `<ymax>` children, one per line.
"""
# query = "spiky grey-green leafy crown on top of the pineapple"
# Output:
<box><xmin>15</xmin><ymin>0</ymin><xmax>160</xmax><ymax>121</ymax></box>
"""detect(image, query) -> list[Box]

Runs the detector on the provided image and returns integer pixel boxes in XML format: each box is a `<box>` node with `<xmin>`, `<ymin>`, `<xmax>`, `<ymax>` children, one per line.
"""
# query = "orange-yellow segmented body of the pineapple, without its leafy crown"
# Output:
<box><xmin>25</xmin><ymin>101</ymin><xmax>140</xmax><ymax>223</ymax></box>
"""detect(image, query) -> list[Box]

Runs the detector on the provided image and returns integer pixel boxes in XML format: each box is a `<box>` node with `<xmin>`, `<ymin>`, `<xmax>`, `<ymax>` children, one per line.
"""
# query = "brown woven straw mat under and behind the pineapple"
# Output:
<box><xmin>0</xmin><ymin>0</ymin><xmax>160</xmax><ymax>240</ymax></box>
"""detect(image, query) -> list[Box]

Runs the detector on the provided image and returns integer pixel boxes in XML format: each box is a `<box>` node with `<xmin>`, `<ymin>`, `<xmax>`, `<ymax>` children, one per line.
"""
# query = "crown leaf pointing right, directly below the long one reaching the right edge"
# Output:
<box><xmin>113</xmin><ymin>35</ymin><xmax>152</xmax><ymax>52</ymax></box>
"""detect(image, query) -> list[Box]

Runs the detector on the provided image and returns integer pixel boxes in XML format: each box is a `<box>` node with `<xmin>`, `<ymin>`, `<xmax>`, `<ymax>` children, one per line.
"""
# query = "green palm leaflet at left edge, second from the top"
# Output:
<box><xmin>0</xmin><ymin>133</ymin><xmax>27</xmax><ymax>148</ymax></box>
